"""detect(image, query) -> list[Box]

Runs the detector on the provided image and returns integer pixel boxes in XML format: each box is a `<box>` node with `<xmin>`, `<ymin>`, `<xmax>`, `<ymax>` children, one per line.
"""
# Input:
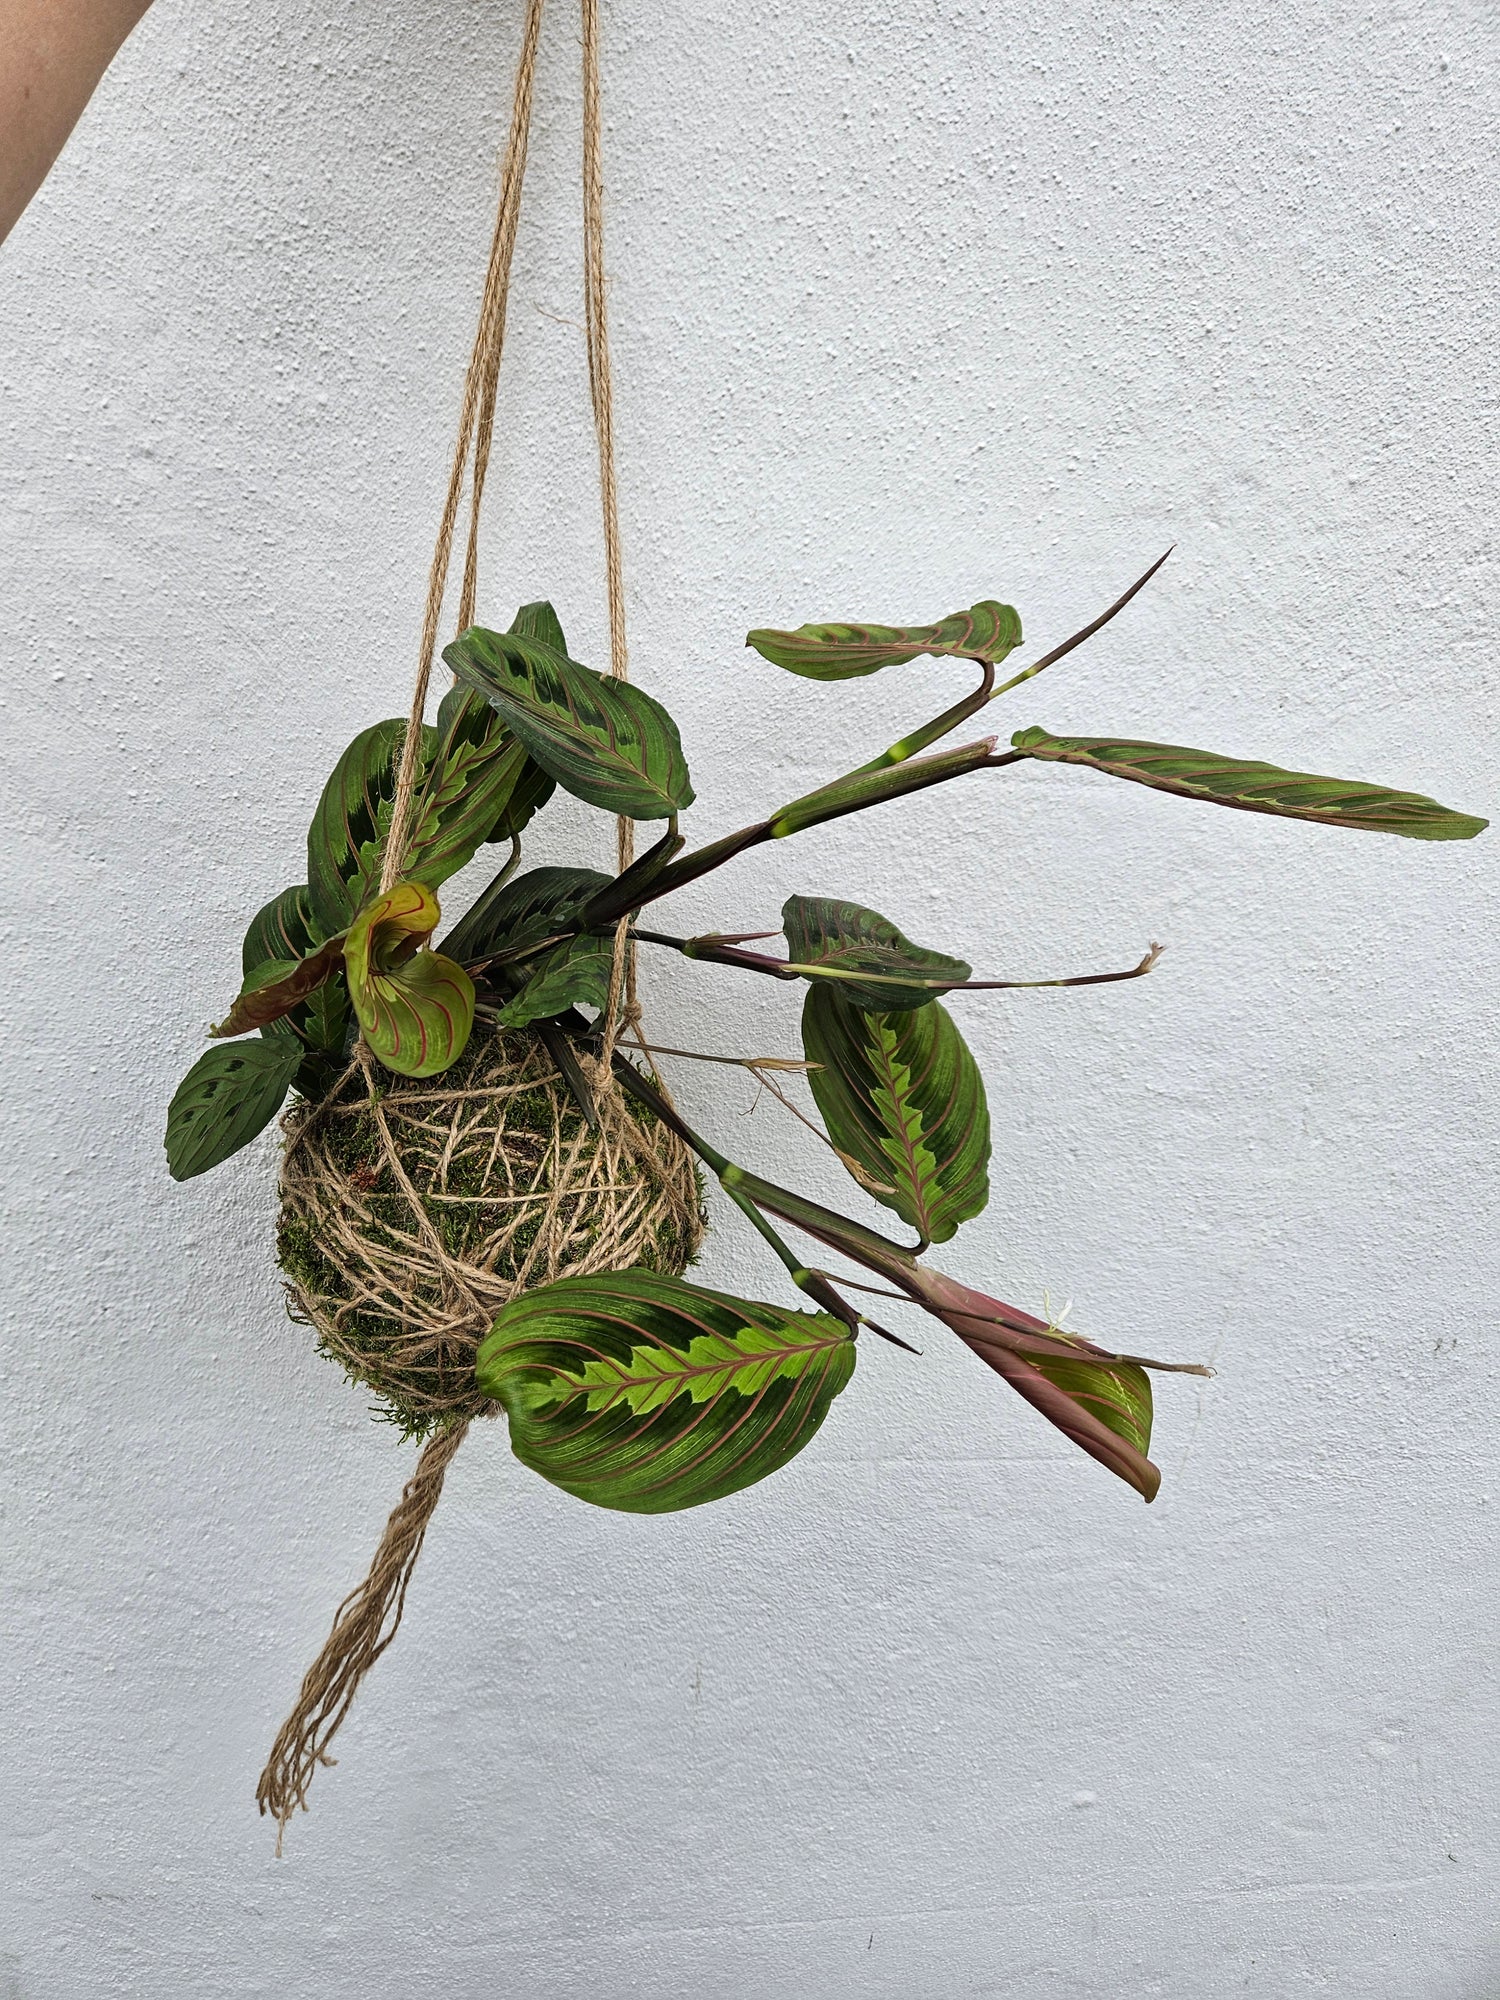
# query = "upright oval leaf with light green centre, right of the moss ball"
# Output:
<box><xmin>802</xmin><ymin>986</ymin><xmax>990</xmax><ymax>1244</ymax></box>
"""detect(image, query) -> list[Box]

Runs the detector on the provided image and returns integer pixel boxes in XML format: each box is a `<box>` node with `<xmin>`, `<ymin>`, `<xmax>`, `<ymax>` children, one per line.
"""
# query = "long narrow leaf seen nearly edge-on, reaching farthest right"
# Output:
<box><xmin>1010</xmin><ymin>730</ymin><xmax>1490</xmax><ymax>840</ymax></box>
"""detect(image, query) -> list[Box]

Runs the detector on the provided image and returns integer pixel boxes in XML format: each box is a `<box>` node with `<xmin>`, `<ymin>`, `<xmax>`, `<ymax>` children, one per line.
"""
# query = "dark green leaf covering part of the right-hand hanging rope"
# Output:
<box><xmin>442</xmin><ymin>626</ymin><xmax>692</xmax><ymax>820</ymax></box>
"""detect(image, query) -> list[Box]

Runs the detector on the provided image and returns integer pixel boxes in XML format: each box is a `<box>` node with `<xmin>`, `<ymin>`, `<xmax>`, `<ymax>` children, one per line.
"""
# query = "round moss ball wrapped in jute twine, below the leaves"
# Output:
<box><xmin>278</xmin><ymin>1026</ymin><xmax>704</xmax><ymax>1436</ymax></box>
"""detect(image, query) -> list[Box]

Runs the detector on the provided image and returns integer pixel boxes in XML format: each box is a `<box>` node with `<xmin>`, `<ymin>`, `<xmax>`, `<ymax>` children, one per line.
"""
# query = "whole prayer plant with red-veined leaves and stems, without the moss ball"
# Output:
<box><xmin>166</xmin><ymin>558</ymin><xmax>1486</xmax><ymax>1512</ymax></box>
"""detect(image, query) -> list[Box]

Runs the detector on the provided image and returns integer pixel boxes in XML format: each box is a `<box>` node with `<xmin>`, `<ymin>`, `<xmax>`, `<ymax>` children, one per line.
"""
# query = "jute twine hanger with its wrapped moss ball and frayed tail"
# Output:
<box><xmin>256</xmin><ymin>0</ymin><xmax>688</xmax><ymax>1852</ymax></box>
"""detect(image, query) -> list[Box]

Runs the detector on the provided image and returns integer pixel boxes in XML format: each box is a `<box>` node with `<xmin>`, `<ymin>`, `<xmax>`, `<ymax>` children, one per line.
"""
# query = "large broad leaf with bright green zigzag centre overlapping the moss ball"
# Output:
<box><xmin>478</xmin><ymin>1270</ymin><xmax>854</xmax><ymax>1514</ymax></box>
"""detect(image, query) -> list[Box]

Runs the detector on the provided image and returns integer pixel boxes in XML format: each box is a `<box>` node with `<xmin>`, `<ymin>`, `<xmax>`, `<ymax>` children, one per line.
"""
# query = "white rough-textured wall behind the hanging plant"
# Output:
<box><xmin>0</xmin><ymin>0</ymin><xmax>1500</xmax><ymax>2000</ymax></box>
